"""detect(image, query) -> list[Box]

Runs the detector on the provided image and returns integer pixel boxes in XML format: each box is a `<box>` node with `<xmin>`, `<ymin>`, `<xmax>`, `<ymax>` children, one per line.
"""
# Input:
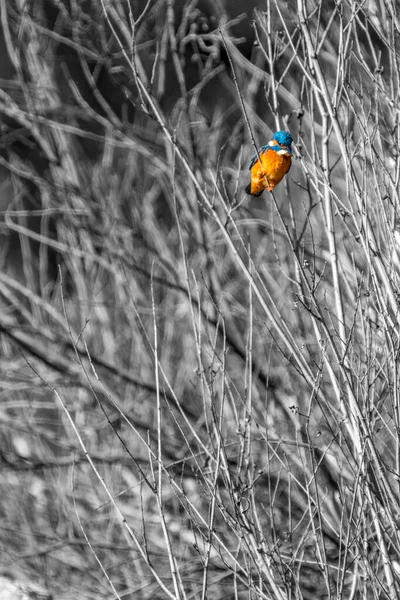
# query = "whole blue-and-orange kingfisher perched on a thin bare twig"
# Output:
<box><xmin>245</xmin><ymin>131</ymin><xmax>293</xmax><ymax>197</ymax></box>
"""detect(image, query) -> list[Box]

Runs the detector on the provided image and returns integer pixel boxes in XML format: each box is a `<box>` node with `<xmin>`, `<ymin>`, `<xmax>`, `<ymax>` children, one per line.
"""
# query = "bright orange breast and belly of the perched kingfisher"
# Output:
<box><xmin>250</xmin><ymin>149</ymin><xmax>292</xmax><ymax>194</ymax></box>
